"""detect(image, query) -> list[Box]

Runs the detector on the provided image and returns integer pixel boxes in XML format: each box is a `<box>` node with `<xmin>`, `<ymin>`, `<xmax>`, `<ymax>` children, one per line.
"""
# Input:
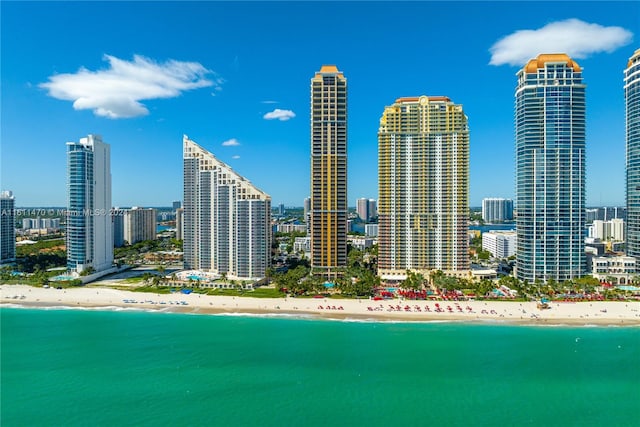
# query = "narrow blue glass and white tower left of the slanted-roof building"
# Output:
<box><xmin>66</xmin><ymin>135</ymin><xmax>113</xmax><ymax>273</ymax></box>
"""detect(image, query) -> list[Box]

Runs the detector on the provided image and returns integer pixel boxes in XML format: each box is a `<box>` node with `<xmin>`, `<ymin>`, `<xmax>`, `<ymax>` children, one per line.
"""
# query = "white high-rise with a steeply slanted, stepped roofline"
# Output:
<box><xmin>182</xmin><ymin>135</ymin><xmax>271</xmax><ymax>279</ymax></box>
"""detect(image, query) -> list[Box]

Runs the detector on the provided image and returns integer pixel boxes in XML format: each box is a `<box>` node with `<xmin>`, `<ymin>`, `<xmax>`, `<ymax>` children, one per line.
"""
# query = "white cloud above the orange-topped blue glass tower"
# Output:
<box><xmin>489</xmin><ymin>18</ymin><xmax>633</xmax><ymax>66</ymax></box>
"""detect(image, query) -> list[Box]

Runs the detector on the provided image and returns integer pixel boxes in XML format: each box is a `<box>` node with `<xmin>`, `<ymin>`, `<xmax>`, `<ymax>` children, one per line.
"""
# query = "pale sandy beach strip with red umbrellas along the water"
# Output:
<box><xmin>0</xmin><ymin>285</ymin><xmax>640</xmax><ymax>325</ymax></box>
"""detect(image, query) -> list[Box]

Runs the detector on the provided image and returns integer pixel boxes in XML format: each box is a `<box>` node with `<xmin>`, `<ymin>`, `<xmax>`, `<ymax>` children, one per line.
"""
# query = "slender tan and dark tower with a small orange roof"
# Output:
<box><xmin>310</xmin><ymin>65</ymin><xmax>348</xmax><ymax>274</ymax></box>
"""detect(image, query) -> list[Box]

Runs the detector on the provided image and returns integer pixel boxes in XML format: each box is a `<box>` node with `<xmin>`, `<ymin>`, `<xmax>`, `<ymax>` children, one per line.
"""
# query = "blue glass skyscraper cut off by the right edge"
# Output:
<box><xmin>624</xmin><ymin>49</ymin><xmax>640</xmax><ymax>259</ymax></box>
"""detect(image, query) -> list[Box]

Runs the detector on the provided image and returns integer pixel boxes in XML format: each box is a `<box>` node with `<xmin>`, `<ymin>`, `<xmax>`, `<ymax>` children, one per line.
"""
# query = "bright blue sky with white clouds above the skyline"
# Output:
<box><xmin>0</xmin><ymin>1</ymin><xmax>640</xmax><ymax>206</ymax></box>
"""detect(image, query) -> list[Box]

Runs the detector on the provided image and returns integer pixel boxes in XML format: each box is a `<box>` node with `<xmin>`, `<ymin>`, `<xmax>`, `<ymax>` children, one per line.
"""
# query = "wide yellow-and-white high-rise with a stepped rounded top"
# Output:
<box><xmin>378</xmin><ymin>96</ymin><xmax>469</xmax><ymax>278</ymax></box>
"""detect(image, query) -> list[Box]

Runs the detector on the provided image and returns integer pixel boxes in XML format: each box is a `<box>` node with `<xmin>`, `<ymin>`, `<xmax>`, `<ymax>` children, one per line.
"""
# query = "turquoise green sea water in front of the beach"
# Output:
<box><xmin>0</xmin><ymin>308</ymin><xmax>640</xmax><ymax>427</ymax></box>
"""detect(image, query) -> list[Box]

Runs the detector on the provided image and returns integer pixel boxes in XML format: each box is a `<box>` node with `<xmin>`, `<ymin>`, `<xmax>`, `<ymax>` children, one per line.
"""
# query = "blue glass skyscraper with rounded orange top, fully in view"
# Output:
<box><xmin>515</xmin><ymin>54</ymin><xmax>586</xmax><ymax>283</ymax></box>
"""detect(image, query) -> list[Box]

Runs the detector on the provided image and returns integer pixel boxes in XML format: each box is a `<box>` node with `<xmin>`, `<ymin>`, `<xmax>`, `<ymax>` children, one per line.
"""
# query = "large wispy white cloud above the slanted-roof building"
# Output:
<box><xmin>39</xmin><ymin>55</ymin><xmax>223</xmax><ymax>119</ymax></box>
